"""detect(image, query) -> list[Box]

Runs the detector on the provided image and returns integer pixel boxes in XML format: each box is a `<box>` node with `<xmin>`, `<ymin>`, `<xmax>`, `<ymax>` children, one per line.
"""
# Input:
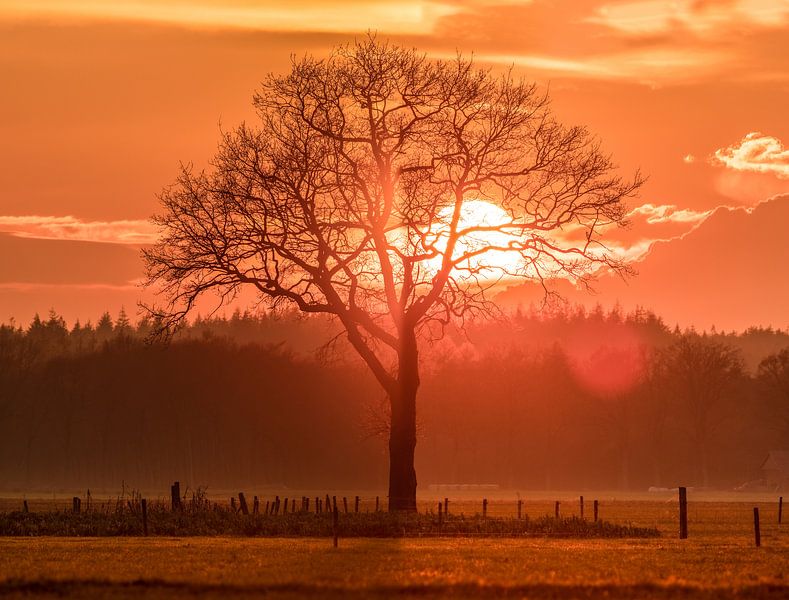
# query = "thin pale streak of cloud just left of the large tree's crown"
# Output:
<box><xmin>0</xmin><ymin>215</ymin><xmax>157</xmax><ymax>244</ymax></box>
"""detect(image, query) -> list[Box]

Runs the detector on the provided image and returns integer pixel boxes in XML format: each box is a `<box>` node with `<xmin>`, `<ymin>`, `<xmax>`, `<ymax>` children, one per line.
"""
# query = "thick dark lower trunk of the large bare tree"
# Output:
<box><xmin>389</xmin><ymin>331</ymin><xmax>419</xmax><ymax>512</ymax></box>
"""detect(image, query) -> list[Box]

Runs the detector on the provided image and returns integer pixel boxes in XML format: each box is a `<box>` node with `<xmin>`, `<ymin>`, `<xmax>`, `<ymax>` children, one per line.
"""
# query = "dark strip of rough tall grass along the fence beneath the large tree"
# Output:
<box><xmin>0</xmin><ymin>495</ymin><xmax>660</xmax><ymax>538</ymax></box>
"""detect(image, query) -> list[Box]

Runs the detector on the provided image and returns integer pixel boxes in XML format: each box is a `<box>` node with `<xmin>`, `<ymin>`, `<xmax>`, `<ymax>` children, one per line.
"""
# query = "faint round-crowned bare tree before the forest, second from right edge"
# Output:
<box><xmin>658</xmin><ymin>333</ymin><xmax>744</xmax><ymax>487</ymax></box>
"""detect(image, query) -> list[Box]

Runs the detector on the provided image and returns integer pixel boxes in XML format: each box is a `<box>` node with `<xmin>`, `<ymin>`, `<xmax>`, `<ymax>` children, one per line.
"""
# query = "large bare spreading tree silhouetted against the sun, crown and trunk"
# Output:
<box><xmin>145</xmin><ymin>36</ymin><xmax>641</xmax><ymax>510</ymax></box>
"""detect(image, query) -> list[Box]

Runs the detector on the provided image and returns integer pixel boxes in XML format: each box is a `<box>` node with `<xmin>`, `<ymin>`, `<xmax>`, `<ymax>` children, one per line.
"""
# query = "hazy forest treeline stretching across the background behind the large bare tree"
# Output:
<box><xmin>0</xmin><ymin>309</ymin><xmax>789</xmax><ymax>491</ymax></box>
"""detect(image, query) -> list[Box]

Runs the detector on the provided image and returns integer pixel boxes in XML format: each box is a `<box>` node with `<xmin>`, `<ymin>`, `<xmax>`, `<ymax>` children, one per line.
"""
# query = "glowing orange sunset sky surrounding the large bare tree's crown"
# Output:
<box><xmin>0</xmin><ymin>0</ymin><xmax>789</xmax><ymax>329</ymax></box>
